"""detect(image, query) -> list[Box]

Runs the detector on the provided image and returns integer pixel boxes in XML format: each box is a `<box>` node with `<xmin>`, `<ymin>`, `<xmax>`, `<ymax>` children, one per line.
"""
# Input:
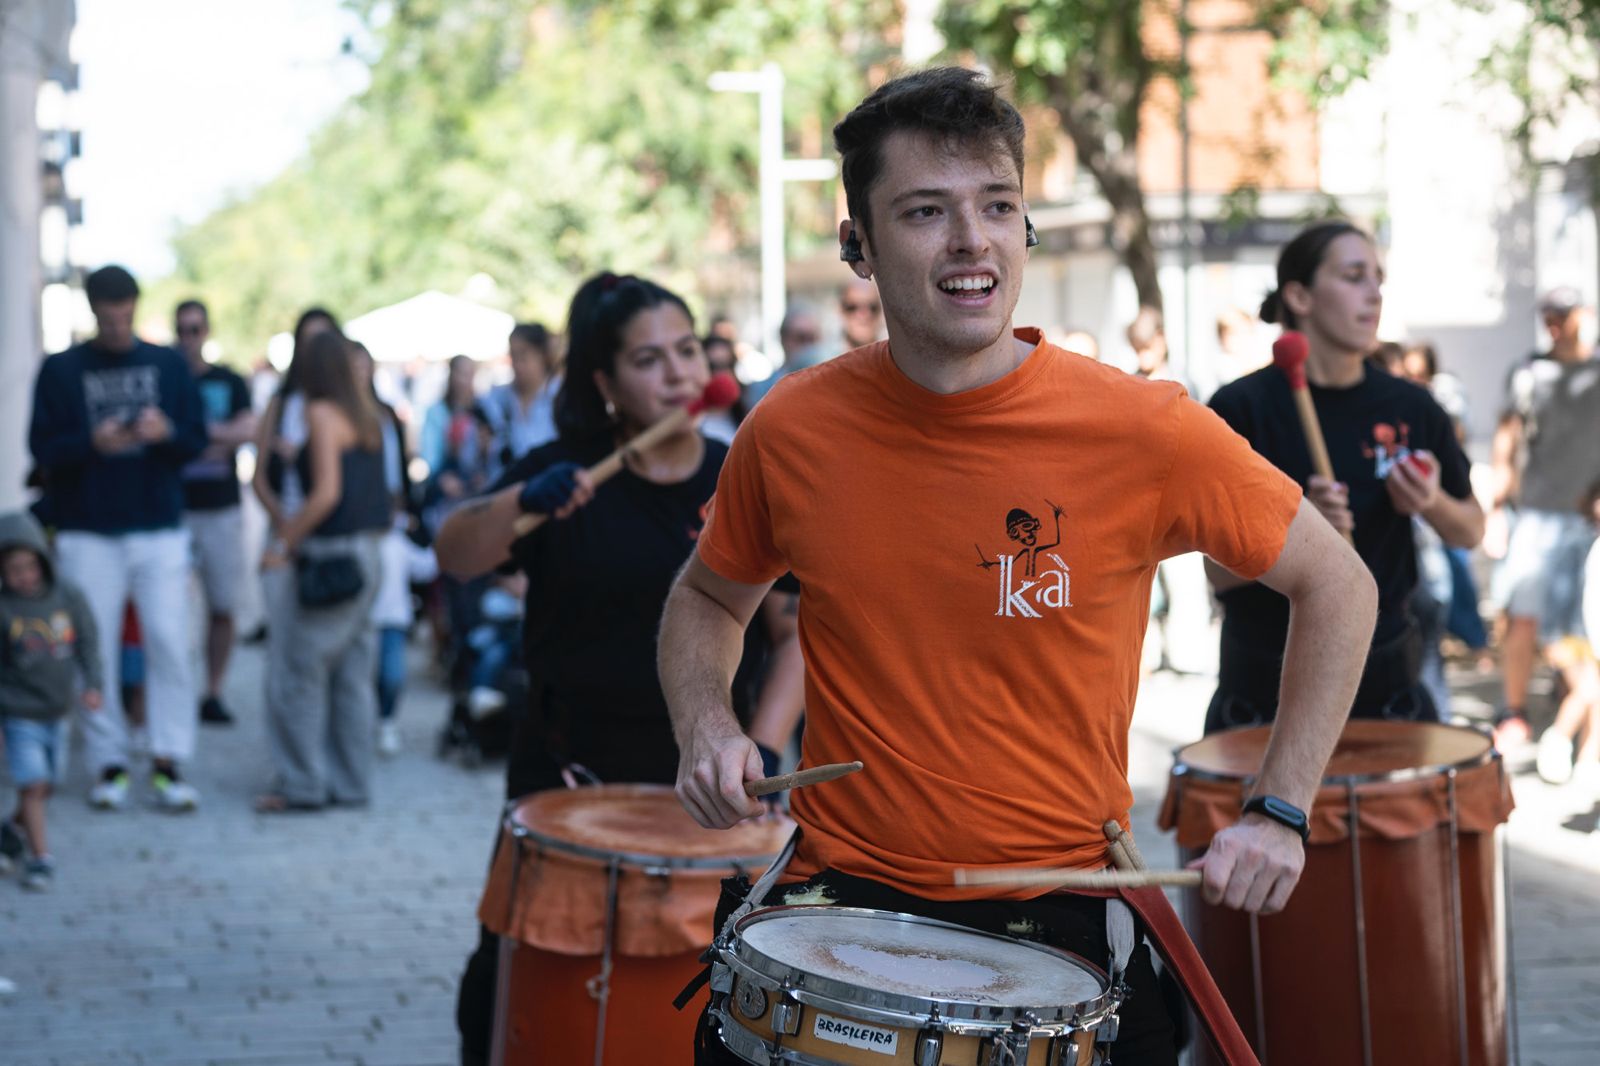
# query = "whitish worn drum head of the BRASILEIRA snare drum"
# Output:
<box><xmin>738</xmin><ymin>908</ymin><xmax>1106</xmax><ymax>1010</ymax></box>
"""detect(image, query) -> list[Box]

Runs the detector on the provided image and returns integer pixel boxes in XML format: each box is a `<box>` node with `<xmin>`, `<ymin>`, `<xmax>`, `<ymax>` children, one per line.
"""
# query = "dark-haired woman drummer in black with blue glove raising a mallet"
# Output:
<box><xmin>434</xmin><ymin>274</ymin><xmax>803</xmax><ymax>1063</ymax></box>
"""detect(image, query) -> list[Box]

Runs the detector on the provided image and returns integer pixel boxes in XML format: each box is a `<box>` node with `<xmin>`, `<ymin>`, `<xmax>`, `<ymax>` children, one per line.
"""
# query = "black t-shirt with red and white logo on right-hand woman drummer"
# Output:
<box><xmin>1211</xmin><ymin>367</ymin><xmax>1472</xmax><ymax>653</ymax></box>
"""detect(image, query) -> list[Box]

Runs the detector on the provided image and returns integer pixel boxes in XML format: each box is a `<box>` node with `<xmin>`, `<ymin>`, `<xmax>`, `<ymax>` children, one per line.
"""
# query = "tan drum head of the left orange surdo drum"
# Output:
<box><xmin>506</xmin><ymin>784</ymin><xmax>794</xmax><ymax>866</ymax></box>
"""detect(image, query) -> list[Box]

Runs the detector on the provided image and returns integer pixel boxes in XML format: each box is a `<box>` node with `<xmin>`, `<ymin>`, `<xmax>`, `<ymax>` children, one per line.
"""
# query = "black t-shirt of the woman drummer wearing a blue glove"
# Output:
<box><xmin>491</xmin><ymin>439</ymin><xmax>784</xmax><ymax>797</ymax></box>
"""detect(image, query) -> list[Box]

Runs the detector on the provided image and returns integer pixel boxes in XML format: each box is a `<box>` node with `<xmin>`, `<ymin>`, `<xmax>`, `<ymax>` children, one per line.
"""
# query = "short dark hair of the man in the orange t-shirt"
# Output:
<box><xmin>834</xmin><ymin>67</ymin><xmax>1024</xmax><ymax>235</ymax></box>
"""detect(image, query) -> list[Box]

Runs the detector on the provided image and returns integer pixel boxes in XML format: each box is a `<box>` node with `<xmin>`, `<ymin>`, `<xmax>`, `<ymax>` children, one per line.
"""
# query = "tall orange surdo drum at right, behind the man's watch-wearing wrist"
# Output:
<box><xmin>1162</xmin><ymin>720</ymin><xmax>1512</xmax><ymax>1066</ymax></box>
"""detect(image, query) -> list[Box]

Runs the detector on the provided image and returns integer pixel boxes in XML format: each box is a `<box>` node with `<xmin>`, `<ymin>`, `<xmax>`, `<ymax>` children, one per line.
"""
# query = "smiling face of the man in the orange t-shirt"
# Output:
<box><xmin>861</xmin><ymin>131</ymin><xmax>1027</xmax><ymax>359</ymax></box>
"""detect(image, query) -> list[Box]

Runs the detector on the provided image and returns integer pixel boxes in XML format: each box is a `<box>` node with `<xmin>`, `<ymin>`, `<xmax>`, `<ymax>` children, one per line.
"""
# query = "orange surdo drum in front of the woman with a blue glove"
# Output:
<box><xmin>478</xmin><ymin>784</ymin><xmax>794</xmax><ymax>1066</ymax></box>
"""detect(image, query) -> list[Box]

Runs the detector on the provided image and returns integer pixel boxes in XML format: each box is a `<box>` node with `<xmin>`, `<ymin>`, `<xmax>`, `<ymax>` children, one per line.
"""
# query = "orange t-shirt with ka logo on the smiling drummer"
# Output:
<box><xmin>698</xmin><ymin>330</ymin><xmax>1301</xmax><ymax>900</ymax></box>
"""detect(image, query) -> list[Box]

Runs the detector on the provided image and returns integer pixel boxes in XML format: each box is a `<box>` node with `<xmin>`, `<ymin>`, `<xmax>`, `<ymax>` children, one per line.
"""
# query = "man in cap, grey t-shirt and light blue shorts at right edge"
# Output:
<box><xmin>1493</xmin><ymin>285</ymin><xmax>1600</xmax><ymax>751</ymax></box>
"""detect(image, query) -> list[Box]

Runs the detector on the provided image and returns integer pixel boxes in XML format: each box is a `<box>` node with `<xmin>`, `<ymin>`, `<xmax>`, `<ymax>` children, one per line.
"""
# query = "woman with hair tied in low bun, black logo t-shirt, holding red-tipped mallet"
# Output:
<box><xmin>1205</xmin><ymin>222</ymin><xmax>1483</xmax><ymax>733</ymax></box>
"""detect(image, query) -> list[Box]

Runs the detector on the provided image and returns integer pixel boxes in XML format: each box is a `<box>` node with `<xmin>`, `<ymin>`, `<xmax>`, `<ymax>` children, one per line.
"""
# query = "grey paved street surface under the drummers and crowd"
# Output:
<box><xmin>0</xmin><ymin>633</ymin><xmax>1600</xmax><ymax>1066</ymax></box>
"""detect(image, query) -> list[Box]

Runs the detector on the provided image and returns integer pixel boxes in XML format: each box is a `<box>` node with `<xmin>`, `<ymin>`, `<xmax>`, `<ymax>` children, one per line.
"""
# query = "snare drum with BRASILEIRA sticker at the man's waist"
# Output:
<box><xmin>710</xmin><ymin>906</ymin><xmax>1115</xmax><ymax>1066</ymax></box>
